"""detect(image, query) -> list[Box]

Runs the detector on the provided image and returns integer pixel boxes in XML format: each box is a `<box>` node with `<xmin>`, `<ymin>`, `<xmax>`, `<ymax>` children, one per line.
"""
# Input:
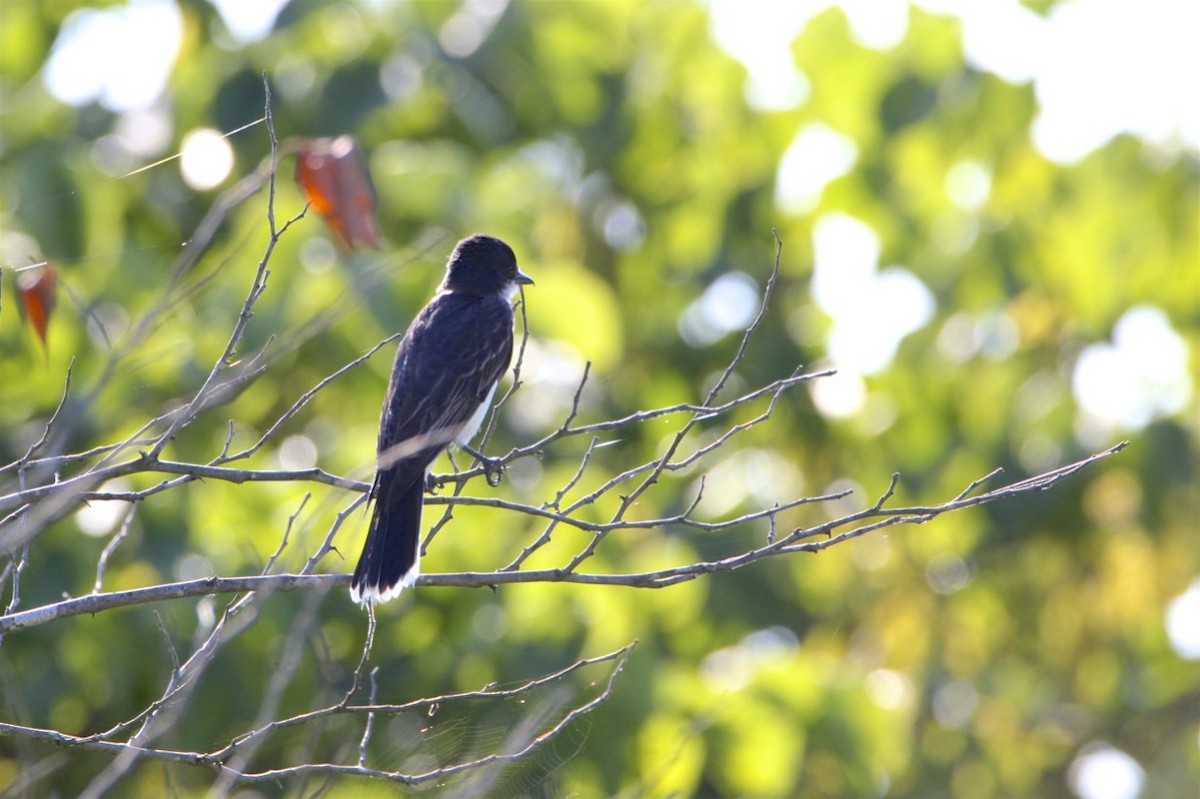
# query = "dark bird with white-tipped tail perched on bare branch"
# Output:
<box><xmin>350</xmin><ymin>235</ymin><xmax>533</xmax><ymax>605</ymax></box>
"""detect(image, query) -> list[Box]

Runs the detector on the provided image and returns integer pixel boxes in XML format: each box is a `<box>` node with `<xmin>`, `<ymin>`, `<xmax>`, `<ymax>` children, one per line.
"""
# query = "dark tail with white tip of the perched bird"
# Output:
<box><xmin>350</xmin><ymin>474</ymin><xmax>425</xmax><ymax>597</ymax></box>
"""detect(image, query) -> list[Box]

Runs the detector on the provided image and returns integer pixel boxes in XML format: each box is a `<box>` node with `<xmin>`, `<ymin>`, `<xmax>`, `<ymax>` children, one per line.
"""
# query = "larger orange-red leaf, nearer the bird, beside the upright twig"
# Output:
<box><xmin>296</xmin><ymin>136</ymin><xmax>379</xmax><ymax>250</ymax></box>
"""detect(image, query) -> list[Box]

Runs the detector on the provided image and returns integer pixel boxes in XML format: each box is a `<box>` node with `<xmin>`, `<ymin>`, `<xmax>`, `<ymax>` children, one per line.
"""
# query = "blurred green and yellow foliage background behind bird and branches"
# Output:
<box><xmin>0</xmin><ymin>0</ymin><xmax>1200</xmax><ymax>799</ymax></box>
